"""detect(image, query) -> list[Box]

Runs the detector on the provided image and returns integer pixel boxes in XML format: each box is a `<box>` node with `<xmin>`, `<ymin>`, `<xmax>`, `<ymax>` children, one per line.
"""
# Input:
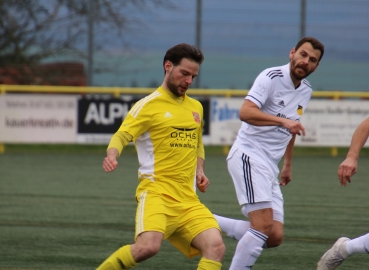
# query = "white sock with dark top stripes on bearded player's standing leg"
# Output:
<box><xmin>229</xmin><ymin>228</ymin><xmax>268</xmax><ymax>270</ymax></box>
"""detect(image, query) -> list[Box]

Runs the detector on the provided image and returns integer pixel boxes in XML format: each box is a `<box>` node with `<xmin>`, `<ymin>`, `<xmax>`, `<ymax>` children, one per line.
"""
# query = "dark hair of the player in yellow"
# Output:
<box><xmin>163</xmin><ymin>43</ymin><xmax>204</xmax><ymax>73</ymax></box>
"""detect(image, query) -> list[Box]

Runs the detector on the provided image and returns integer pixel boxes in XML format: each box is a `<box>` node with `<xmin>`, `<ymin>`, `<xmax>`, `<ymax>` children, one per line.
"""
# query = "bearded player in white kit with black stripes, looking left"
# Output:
<box><xmin>214</xmin><ymin>37</ymin><xmax>324</xmax><ymax>270</ymax></box>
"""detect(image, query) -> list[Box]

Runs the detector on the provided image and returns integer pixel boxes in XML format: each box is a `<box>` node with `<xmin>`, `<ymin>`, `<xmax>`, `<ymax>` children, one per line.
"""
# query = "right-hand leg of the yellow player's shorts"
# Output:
<box><xmin>168</xmin><ymin>201</ymin><xmax>221</xmax><ymax>258</ymax></box>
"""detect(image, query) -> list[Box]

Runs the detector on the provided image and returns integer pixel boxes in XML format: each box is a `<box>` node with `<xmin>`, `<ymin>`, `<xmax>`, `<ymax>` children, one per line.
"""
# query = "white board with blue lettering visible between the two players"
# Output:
<box><xmin>210</xmin><ymin>97</ymin><xmax>244</xmax><ymax>145</ymax></box>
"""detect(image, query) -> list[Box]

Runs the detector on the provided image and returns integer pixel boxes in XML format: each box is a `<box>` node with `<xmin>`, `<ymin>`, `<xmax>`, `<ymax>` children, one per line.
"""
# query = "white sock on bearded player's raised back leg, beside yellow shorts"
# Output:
<box><xmin>213</xmin><ymin>214</ymin><xmax>250</xmax><ymax>241</ymax></box>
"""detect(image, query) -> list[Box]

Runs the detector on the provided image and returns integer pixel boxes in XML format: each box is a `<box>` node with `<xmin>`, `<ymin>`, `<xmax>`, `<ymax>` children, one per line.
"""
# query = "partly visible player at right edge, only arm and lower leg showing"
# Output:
<box><xmin>317</xmin><ymin>117</ymin><xmax>369</xmax><ymax>270</ymax></box>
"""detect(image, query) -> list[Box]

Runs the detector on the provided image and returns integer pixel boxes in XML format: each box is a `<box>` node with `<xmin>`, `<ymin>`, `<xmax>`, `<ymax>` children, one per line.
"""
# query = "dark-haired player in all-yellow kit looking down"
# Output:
<box><xmin>97</xmin><ymin>43</ymin><xmax>225</xmax><ymax>270</ymax></box>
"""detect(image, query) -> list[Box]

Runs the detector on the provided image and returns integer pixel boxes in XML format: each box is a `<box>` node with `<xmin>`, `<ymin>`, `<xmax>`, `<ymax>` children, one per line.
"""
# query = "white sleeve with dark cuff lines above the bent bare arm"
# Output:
<box><xmin>245</xmin><ymin>71</ymin><xmax>272</xmax><ymax>108</ymax></box>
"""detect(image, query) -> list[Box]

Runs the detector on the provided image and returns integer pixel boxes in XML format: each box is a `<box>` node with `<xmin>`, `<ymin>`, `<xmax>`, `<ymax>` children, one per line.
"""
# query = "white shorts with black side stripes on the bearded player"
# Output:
<box><xmin>227</xmin><ymin>150</ymin><xmax>284</xmax><ymax>217</ymax></box>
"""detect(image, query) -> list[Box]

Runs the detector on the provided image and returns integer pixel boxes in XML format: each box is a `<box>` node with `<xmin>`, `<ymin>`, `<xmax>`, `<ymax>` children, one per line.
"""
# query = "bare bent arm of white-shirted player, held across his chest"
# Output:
<box><xmin>240</xmin><ymin>99</ymin><xmax>305</xmax><ymax>135</ymax></box>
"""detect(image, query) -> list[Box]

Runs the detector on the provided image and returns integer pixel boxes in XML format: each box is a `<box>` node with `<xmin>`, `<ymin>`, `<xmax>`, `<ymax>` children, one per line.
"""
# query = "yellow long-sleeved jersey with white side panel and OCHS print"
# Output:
<box><xmin>109</xmin><ymin>87</ymin><xmax>204</xmax><ymax>201</ymax></box>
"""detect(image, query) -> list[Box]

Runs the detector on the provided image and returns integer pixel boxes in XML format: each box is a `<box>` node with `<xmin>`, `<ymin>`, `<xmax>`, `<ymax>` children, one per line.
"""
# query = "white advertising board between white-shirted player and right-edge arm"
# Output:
<box><xmin>295</xmin><ymin>100</ymin><xmax>369</xmax><ymax>147</ymax></box>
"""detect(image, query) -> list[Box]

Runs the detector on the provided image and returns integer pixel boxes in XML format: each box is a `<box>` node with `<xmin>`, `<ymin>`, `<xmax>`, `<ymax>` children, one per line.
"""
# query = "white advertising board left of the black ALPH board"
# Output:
<box><xmin>0</xmin><ymin>94</ymin><xmax>77</xmax><ymax>143</ymax></box>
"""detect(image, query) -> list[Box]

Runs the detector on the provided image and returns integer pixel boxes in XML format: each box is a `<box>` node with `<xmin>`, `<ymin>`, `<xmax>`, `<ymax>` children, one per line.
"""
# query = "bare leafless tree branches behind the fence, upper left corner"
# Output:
<box><xmin>0</xmin><ymin>0</ymin><xmax>176</xmax><ymax>67</ymax></box>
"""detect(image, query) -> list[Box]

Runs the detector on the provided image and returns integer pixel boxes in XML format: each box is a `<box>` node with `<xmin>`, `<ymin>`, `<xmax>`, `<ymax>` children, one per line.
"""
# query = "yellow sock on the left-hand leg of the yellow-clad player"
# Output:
<box><xmin>96</xmin><ymin>245</ymin><xmax>137</xmax><ymax>270</ymax></box>
